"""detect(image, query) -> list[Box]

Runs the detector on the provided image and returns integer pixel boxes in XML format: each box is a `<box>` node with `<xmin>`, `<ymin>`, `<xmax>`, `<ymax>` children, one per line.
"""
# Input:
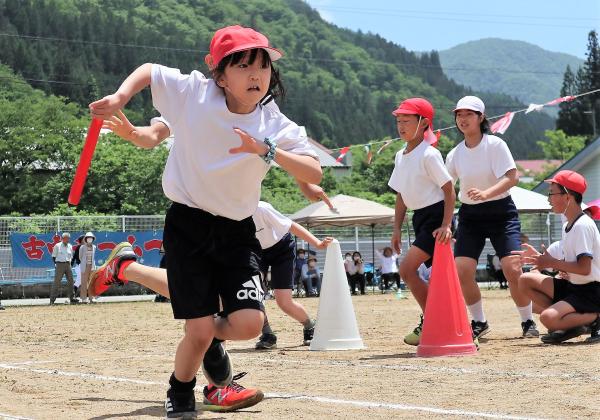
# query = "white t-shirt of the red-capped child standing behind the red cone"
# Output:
<box><xmin>388</xmin><ymin>141</ymin><xmax>452</xmax><ymax>210</ymax></box>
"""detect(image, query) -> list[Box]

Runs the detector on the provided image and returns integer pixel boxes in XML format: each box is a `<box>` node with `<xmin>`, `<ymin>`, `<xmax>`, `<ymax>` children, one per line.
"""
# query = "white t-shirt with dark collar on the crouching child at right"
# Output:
<box><xmin>561</xmin><ymin>215</ymin><xmax>600</xmax><ymax>284</ymax></box>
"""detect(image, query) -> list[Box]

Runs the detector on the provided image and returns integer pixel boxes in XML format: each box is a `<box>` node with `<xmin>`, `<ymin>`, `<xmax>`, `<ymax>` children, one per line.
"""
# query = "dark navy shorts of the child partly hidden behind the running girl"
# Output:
<box><xmin>260</xmin><ymin>233</ymin><xmax>296</xmax><ymax>290</ymax></box>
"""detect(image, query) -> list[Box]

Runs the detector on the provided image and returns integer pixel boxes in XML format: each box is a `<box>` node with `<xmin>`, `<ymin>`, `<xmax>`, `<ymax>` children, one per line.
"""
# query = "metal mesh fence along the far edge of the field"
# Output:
<box><xmin>0</xmin><ymin>213</ymin><xmax>592</xmax><ymax>283</ymax></box>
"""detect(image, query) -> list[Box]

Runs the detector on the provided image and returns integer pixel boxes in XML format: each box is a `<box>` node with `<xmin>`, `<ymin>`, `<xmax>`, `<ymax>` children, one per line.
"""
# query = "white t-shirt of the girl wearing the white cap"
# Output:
<box><xmin>446</xmin><ymin>134</ymin><xmax>517</xmax><ymax>204</ymax></box>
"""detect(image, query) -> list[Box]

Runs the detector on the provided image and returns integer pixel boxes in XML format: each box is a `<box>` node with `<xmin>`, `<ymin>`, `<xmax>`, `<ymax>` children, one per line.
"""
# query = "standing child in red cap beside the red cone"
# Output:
<box><xmin>388</xmin><ymin>98</ymin><xmax>456</xmax><ymax>346</ymax></box>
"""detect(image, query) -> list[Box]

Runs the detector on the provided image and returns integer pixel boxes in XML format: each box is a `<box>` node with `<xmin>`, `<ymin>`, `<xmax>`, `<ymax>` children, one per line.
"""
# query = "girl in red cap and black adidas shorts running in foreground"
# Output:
<box><xmin>90</xmin><ymin>26</ymin><xmax>322</xmax><ymax>418</ymax></box>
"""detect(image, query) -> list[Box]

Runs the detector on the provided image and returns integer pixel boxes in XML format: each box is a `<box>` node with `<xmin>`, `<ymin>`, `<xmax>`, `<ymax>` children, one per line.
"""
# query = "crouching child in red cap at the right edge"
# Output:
<box><xmin>519</xmin><ymin>171</ymin><xmax>600</xmax><ymax>344</ymax></box>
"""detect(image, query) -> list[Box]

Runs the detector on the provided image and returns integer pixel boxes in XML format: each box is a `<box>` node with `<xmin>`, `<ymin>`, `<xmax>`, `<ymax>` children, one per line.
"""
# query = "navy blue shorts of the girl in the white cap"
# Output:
<box><xmin>454</xmin><ymin>196</ymin><xmax>521</xmax><ymax>260</ymax></box>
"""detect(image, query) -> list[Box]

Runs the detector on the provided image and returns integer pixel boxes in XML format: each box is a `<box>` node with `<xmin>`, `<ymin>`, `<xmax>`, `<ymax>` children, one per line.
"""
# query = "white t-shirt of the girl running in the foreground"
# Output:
<box><xmin>151</xmin><ymin>64</ymin><xmax>317</xmax><ymax>220</ymax></box>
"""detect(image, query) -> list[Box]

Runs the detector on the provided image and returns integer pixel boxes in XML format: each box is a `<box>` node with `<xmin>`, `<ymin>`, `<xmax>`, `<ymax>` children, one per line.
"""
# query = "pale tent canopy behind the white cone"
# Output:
<box><xmin>290</xmin><ymin>194</ymin><xmax>394</xmax><ymax>226</ymax></box>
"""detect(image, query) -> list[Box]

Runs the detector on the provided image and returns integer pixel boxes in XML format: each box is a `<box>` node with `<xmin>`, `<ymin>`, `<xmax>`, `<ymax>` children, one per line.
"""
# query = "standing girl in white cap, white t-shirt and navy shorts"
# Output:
<box><xmin>446</xmin><ymin>96</ymin><xmax>539</xmax><ymax>338</ymax></box>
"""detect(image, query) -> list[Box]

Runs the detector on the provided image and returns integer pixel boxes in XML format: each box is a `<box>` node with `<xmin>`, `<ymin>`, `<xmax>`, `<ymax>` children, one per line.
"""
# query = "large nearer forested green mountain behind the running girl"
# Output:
<box><xmin>0</xmin><ymin>0</ymin><xmax>554</xmax><ymax>158</ymax></box>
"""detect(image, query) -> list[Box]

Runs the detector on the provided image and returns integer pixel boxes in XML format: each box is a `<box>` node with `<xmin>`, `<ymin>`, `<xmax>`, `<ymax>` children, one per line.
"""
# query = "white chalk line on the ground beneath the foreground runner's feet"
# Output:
<box><xmin>0</xmin><ymin>363</ymin><xmax>542</xmax><ymax>420</ymax></box>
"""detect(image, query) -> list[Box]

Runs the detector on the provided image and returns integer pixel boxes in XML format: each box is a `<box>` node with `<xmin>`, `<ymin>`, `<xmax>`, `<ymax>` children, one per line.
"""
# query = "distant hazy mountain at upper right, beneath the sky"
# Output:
<box><xmin>440</xmin><ymin>38</ymin><xmax>583</xmax><ymax>110</ymax></box>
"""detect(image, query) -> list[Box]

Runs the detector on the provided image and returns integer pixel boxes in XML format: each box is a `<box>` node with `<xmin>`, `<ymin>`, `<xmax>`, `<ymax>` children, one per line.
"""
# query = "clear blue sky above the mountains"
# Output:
<box><xmin>307</xmin><ymin>0</ymin><xmax>600</xmax><ymax>58</ymax></box>
